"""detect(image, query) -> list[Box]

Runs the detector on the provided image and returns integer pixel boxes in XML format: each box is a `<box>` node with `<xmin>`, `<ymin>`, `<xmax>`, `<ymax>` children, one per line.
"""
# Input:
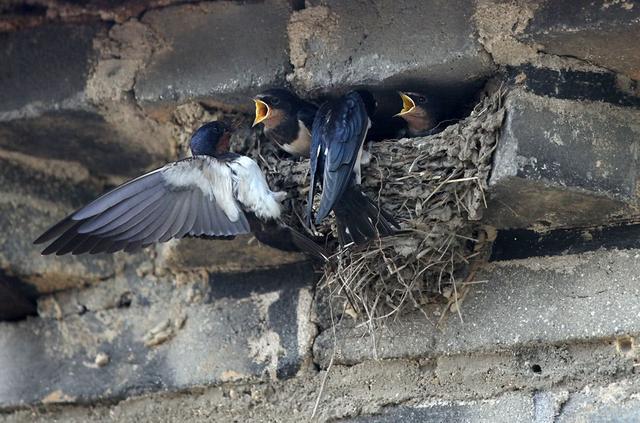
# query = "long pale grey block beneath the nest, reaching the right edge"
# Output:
<box><xmin>314</xmin><ymin>250</ymin><xmax>640</xmax><ymax>367</ymax></box>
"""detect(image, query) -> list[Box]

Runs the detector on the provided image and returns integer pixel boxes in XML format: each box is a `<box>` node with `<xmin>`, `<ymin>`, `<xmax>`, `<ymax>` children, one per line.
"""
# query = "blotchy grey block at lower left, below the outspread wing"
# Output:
<box><xmin>0</xmin><ymin>266</ymin><xmax>315</xmax><ymax>408</ymax></box>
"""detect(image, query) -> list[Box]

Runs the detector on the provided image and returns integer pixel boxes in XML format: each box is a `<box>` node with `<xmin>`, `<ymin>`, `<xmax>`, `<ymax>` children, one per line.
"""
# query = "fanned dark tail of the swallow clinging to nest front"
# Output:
<box><xmin>334</xmin><ymin>185</ymin><xmax>400</xmax><ymax>245</ymax></box>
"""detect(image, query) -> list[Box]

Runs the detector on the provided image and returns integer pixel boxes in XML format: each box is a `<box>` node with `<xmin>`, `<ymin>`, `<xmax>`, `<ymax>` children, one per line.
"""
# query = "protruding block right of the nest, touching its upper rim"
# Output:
<box><xmin>485</xmin><ymin>90</ymin><xmax>640</xmax><ymax>229</ymax></box>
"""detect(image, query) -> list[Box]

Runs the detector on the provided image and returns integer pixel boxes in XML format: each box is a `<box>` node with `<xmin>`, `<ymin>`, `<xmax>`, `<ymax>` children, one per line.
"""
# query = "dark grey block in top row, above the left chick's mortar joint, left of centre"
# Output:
<box><xmin>135</xmin><ymin>0</ymin><xmax>289</xmax><ymax>116</ymax></box>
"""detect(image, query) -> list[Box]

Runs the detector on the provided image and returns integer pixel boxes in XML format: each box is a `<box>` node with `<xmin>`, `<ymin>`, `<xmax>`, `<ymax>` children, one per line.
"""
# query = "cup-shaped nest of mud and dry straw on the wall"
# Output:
<box><xmin>259</xmin><ymin>90</ymin><xmax>505</xmax><ymax>320</ymax></box>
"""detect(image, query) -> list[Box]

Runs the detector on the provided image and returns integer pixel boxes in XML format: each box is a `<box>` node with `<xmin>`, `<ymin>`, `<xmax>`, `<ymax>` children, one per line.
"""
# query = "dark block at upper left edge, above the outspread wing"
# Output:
<box><xmin>0</xmin><ymin>21</ymin><xmax>169</xmax><ymax>176</ymax></box>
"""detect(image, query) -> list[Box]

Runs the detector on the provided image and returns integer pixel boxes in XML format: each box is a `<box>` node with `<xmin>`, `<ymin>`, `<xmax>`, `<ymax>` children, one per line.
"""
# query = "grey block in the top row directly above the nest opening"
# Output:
<box><xmin>289</xmin><ymin>0</ymin><xmax>494</xmax><ymax>95</ymax></box>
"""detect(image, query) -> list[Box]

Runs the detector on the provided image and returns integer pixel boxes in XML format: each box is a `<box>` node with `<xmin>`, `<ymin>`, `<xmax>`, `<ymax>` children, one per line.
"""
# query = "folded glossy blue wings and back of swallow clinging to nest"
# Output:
<box><xmin>311</xmin><ymin>92</ymin><xmax>369</xmax><ymax>223</ymax></box>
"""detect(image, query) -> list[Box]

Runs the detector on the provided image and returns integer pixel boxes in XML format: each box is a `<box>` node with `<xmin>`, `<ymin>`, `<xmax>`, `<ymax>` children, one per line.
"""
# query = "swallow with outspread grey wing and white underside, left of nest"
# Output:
<box><xmin>35</xmin><ymin>122</ymin><xmax>324</xmax><ymax>255</ymax></box>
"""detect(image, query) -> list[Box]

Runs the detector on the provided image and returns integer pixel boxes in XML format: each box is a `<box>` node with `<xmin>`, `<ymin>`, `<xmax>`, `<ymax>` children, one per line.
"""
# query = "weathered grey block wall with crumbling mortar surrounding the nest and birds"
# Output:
<box><xmin>0</xmin><ymin>0</ymin><xmax>640</xmax><ymax>422</ymax></box>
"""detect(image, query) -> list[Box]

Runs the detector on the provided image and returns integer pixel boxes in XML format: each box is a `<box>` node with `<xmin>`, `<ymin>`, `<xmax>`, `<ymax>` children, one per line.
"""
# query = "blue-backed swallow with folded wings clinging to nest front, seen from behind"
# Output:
<box><xmin>307</xmin><ymin>91</ymin><xmax>398</xmax><ymax>245</ymax></box>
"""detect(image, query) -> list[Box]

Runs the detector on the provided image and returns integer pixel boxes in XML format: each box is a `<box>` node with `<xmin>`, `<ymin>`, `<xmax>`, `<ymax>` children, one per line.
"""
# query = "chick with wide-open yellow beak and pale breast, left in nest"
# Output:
<box><xmin>253</xmin><ymin>88</ymin><xmax>318</xmax><ymax>157</ymax></box>
